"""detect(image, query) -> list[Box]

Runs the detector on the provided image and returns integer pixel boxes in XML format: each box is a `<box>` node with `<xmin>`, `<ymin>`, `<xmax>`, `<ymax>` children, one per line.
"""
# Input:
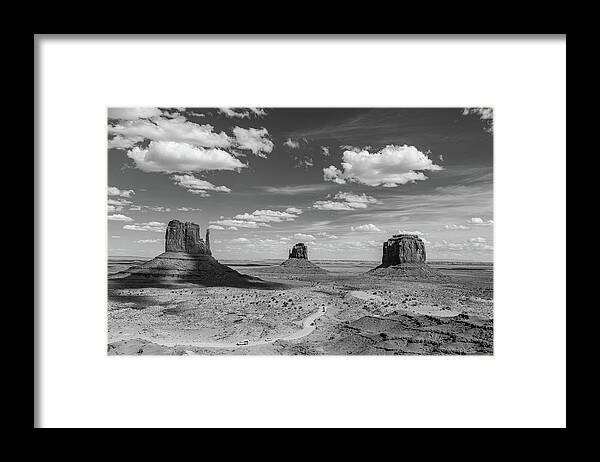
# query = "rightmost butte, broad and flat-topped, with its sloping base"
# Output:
<box><xmin>369</xmin><ymin>234</ymin><xmax>437</xmax><ymax>277</ymax></box>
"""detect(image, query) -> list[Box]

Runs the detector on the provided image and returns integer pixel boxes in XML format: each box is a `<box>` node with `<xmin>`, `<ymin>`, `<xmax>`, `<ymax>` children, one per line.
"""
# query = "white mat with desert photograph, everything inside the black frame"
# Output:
<box><xmin>34</xmin><ymin>35</ymin><xmax>566</xmax><ymax>428</ymax></box>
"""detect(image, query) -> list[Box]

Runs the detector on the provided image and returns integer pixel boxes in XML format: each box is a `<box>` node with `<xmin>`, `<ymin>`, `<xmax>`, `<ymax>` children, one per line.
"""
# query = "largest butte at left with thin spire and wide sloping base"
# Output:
<box><xmin>109</xmin><ymin>220</ymin><xmax>264</xmax><ymax>287</ymax></box>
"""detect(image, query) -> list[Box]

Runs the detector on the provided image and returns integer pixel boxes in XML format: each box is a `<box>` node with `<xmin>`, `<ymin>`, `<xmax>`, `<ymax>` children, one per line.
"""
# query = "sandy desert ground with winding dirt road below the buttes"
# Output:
<box><xmin>108</xmin><ymin>263</ymin><xmax>493</xmax><ymax>355</ymax></box>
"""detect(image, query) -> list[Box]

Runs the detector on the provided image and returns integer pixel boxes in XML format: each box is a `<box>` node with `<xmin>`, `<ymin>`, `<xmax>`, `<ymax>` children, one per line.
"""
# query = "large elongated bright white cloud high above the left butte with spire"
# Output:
<box><xmin>127</xmin><ymin>141</ymin><xmax>246</xmax><ymax>173</ymax></box>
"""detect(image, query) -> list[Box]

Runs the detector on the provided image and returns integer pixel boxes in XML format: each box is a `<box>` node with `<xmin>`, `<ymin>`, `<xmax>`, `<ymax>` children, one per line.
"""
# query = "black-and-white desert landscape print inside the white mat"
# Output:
<box><xmin>107</xmin><ymin>107</ymin><xmax>494</xmax><ymax>355</ymax></box>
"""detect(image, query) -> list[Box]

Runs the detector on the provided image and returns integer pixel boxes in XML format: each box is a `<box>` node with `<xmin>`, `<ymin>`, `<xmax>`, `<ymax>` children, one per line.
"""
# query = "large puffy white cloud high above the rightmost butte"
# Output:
<box><xmin>323</xmin><ymin>145</ymin><xmax>442</xmax><ymax>187</ymax></box>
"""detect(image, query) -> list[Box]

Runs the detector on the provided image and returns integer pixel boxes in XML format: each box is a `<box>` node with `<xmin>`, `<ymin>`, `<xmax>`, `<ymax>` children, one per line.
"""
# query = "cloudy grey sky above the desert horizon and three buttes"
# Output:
<box><xmin>107</xmin><ymin>107</ymin><xmax>494</xmax><ymax>261</ymax></box>
